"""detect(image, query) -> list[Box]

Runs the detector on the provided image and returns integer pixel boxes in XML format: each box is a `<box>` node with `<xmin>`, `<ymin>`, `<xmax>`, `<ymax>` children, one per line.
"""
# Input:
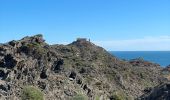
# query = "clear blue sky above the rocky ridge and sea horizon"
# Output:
<box><xmin>0</xmin><ymin>0</ymin><xmax>170</xmax><ymax>51</ymax></box>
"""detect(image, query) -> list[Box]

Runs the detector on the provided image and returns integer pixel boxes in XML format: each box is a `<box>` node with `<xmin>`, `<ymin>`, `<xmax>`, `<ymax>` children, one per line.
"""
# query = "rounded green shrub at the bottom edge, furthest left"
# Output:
<box><xmin>21</xmin><ymin>86</ymin><xmax>44</xmax><ymax>100</ymax></box>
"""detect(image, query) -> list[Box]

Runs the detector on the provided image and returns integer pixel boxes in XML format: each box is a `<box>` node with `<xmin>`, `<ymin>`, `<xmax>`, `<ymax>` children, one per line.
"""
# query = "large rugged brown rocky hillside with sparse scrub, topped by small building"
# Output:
<box><xmin>0</xmin><ymin>35</ymin><xmax>164</xmax><ymax>100</ymax></box>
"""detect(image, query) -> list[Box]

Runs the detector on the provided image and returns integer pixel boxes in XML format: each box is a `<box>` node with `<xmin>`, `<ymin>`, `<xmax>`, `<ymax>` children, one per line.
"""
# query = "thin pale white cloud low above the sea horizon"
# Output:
<box><xmin>93</xmin><ymin>36</ymin><xmax>170</xmax><ymax>51</ymax></box>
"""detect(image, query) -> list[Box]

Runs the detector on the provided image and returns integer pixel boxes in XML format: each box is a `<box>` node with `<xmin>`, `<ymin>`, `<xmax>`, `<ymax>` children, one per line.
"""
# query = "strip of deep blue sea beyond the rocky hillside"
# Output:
<box><xmin>110</xmin><ymin>51</ymin><xmax>170</xmax><ymax>67</ymax></box>
